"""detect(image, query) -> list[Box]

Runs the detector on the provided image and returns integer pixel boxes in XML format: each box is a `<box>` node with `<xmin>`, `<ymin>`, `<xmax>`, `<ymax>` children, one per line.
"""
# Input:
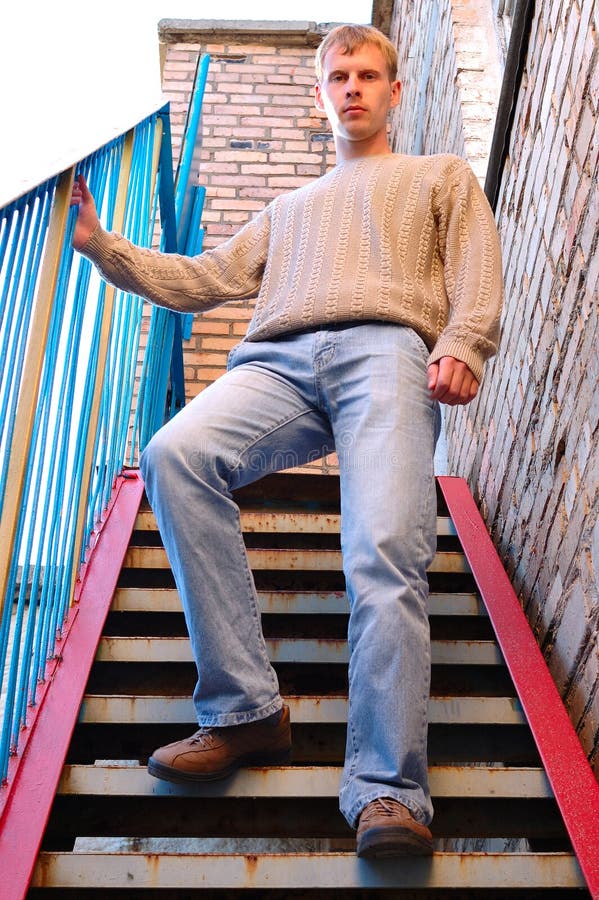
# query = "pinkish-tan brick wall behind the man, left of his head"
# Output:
<box><xmin>160</xmin><ymin>20</ymin><xmax>335</xmax><ymax>398</ymax></box>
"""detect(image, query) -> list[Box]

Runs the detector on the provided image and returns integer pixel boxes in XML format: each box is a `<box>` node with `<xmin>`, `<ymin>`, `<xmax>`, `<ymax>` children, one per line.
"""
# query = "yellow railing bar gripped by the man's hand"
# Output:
<box><xmin>0</xmin><ymin>167</ymin><xmax>75</xmax><ymax>610</ymax></box>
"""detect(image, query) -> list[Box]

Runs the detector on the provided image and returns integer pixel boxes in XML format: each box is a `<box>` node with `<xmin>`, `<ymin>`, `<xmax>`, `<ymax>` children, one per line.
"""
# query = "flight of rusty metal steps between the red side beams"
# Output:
<box><xmin>28</xmin><ymin>474</ymin><xmax>590</xmax><ymax>900</ymax></box>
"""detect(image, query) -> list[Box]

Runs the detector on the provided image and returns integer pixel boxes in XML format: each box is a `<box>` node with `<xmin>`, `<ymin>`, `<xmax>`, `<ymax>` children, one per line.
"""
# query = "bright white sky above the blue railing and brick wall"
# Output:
<box><xmin>0</xmin><ymin>0</ymin><xmax>372</xmax><ymax>206</ymax></box>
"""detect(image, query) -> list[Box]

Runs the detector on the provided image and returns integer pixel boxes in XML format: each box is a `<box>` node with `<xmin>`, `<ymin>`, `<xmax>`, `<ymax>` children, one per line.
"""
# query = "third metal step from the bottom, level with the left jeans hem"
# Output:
<box><xmin>79</xmin><ymin>694</ymin><xmax>526</xmax><ymax>728</ymax></box>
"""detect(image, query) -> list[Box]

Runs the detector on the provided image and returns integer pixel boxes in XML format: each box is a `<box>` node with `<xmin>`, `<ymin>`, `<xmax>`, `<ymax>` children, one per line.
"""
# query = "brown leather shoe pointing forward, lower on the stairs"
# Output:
<box><xmin>356</xmin><ymin>797</ymin><xmax>433</xmax><ymax>858</ymax></box>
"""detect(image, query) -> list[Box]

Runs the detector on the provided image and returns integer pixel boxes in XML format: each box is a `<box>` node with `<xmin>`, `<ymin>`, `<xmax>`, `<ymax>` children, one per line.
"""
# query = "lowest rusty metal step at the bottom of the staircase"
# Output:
<box><xmin>32</xmin><ymin>852</ymin><xmax>585</xmax><ymax>897</ymax></box>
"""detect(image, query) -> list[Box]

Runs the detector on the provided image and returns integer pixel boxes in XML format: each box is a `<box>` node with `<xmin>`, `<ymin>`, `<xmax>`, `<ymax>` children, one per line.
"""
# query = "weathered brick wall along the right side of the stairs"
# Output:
<box><xmin>392</xmin><ymin>0</ymin><xmax>599</xmax><ymax>770</ymax></box>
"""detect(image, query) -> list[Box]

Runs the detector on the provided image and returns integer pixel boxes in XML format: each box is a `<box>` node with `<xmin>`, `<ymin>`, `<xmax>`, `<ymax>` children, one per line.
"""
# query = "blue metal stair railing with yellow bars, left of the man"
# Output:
<box><xmin>0</xmin><ymin>103</ymin><xmax>185</xmax><ymax>783</ymax></box>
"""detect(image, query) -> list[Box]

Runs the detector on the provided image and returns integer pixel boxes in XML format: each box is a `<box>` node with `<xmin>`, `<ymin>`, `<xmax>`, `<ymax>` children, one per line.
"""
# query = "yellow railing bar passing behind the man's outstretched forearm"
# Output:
<box><xmin>68</xmin><ymin>129</ymin><xmax>134</xmax><ymax>604</ymax></box>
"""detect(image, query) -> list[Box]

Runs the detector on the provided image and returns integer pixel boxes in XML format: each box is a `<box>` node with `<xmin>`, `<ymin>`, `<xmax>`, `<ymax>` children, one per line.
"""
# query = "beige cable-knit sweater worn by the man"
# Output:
<box><xmin>82</xmin><ymin>154</ymin><xmax>502</xmax><ymax>381</ymax></box>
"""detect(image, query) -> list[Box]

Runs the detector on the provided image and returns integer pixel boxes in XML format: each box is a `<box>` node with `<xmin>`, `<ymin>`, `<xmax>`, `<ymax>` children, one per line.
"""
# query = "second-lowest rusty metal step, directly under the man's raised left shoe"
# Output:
<box><xmin>58</xmin><ymin>760</ymin><xmax>553</xmax><ymax>799</ymax></box>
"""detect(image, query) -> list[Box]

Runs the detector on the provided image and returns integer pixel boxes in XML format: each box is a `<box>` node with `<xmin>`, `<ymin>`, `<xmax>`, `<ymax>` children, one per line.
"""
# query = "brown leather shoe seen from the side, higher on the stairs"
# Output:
<box><xmin>148</xmin><ymin>706</ymin><xmax>291</xmax><ymax>782</ymax></box>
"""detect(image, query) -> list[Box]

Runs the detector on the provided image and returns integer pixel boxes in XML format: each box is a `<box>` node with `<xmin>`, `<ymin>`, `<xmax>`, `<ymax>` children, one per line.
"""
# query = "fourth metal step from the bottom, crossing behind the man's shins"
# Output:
<box><xmin>96</xmin><ymin>637</ymin><xmax>503</xmax><ymax>666</ymax></box>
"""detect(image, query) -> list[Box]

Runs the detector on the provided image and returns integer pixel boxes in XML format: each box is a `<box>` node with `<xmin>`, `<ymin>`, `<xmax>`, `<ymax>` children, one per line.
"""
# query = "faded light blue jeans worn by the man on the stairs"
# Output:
<box><xmin>141</xmin><ymin>322</ymin><xmax>439</xmax><ymax>826</ymax></box>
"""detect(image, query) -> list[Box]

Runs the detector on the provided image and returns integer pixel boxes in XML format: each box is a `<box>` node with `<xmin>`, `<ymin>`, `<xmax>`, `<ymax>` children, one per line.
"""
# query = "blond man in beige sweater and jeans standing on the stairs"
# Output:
<box><xmin>74</xmin><ymin>26</ymin><xmax>502</xmax><ymax>856</ymax></box>
